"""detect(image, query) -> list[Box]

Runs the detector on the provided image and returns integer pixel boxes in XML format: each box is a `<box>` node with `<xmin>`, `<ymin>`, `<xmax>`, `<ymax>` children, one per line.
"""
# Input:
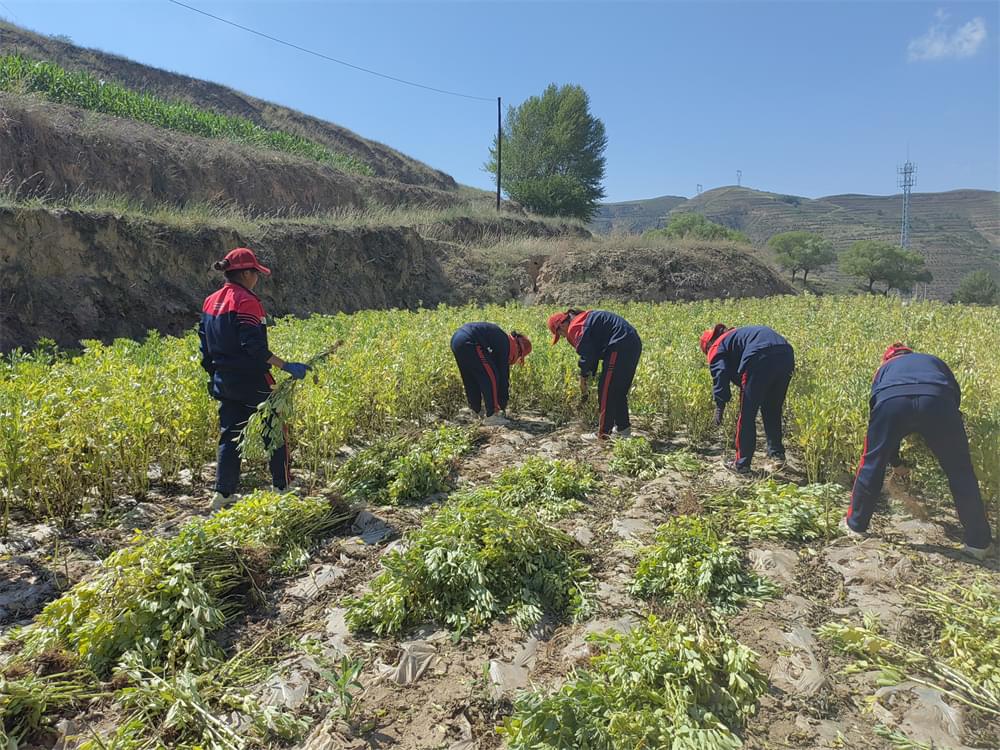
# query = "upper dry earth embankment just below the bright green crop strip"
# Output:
<box><xmin>0</xmin><ymin>93</ymin><xmax>465</xmax><ymax>216</ymax></box>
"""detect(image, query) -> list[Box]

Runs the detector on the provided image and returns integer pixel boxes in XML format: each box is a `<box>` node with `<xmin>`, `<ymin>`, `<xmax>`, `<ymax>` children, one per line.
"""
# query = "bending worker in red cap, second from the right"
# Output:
<box><xmin>700</xmin><ymin>323</ymin><xmax>795</xmax><ymax>474</ymax></box>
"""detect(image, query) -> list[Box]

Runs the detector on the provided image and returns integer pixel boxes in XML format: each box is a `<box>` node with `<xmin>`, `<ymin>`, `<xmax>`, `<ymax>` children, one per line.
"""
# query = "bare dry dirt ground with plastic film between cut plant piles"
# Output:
<box><xmin>0</xmin><ymin>416</ymin><xmax>1000</xmax><ymax>750</ymax></box>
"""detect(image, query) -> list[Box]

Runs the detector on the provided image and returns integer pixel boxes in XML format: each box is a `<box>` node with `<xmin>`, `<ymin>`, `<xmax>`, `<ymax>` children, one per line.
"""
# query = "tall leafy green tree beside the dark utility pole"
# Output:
<box><xmin>485</xmin><ymin>83</ymin><xmax>608</xmax><ymax>221</ymax></box>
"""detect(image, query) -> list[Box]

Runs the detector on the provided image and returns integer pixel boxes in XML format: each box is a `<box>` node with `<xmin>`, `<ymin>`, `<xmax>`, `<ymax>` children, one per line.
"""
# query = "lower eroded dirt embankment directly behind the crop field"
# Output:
<box><xmin>0</xmin><ymin>206</ymin><xmax>788</xmax><ymax>351</ymax></box>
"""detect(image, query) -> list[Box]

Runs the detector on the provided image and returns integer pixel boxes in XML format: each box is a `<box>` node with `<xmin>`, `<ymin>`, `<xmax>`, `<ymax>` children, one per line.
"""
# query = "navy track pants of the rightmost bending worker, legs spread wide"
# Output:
<box><xmin>847</xmin><ymin>396</ymin><xmax>991</xmax><ymax>549</ymax></box>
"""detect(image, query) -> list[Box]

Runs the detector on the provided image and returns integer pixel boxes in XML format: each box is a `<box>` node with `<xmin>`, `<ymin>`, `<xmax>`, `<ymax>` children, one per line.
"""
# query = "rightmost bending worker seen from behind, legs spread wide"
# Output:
<box><xmin>844</xmin><ymin>343</ymin><xmax>991</xmax><ymax>560</ymax></box>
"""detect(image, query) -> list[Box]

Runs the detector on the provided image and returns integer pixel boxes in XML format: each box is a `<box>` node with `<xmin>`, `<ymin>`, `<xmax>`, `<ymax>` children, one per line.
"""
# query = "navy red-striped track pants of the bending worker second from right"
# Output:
<box><xmin>736</xmin><ymin>347</ymin><xmax>795</xmax><ymax>469</ymax></box>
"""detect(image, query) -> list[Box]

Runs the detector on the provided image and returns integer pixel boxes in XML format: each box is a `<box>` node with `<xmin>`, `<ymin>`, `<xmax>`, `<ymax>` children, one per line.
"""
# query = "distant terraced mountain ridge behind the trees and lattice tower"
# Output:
<box><xmin>591</xmin><ymin>186</ymin><xmax>1000</xmax><ymax>299</ymax></box>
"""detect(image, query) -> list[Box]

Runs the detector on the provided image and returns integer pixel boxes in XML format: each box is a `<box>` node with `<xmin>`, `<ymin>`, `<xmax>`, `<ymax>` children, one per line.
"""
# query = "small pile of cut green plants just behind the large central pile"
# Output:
<box><xmin>453</xmin><ymin>456</ymin><xmax>597</xmax><ymax>521</ymax></box>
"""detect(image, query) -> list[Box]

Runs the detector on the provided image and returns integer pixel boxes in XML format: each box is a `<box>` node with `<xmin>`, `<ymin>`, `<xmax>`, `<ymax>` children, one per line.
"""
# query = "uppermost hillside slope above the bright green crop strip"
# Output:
<box><xmin>0</xmin><ymin>22</ymin><xmax>457</xmax><ymax>190</ymax></box>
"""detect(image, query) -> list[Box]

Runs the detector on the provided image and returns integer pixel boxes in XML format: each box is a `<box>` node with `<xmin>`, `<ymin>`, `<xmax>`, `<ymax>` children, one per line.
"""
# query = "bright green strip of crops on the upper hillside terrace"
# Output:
<box><xmin>0</xmin><ymin>55</ymin><xmax>373</xmax><ymax>175</ymax></box>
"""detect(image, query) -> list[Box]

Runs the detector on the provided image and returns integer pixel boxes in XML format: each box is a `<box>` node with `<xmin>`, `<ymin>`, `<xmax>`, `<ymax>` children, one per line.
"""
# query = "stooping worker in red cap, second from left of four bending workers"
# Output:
<box><xmin>548</xmin><ymin>309</ymin><xmax>642</xmax><ymax>439</ymax></box>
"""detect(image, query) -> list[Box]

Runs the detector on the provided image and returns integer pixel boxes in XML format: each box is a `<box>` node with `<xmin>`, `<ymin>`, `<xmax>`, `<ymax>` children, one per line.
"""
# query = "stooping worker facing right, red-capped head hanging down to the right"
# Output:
<box><xmin>451</xmin><ymin>323</ymin><xmax>531</xmax><ymax>426</ymax></box>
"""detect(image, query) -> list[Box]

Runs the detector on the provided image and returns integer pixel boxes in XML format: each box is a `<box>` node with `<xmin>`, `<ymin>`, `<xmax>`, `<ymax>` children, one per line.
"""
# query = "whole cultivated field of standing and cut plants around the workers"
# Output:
<box><xmin>0</xmin><ymin>297</ymin><xmax>1000</xmax><ymax>750</ymax></box>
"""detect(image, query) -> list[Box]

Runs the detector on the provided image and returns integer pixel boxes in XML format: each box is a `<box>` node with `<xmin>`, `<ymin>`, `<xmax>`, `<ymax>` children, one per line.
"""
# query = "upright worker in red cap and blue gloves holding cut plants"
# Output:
<box><xmin>198</xmin><ymin>247</ymin><xmax>309</xmax><ymax>510</ymax></box>
